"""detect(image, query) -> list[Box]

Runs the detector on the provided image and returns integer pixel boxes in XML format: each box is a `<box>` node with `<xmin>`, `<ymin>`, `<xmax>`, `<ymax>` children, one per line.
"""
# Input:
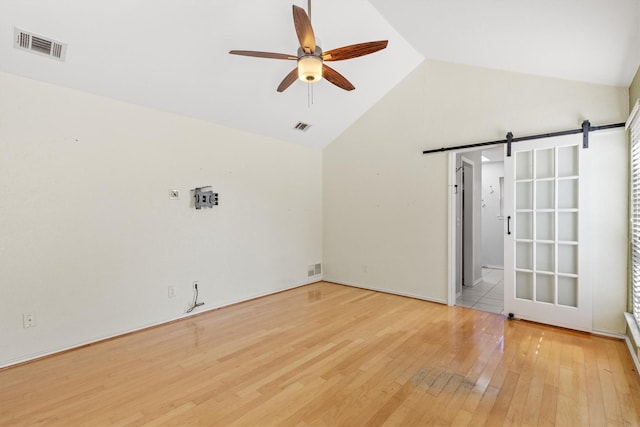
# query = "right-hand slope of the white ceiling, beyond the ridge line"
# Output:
<box><xmin>371</xmin><ymin>0</ymin><xmax>640</xmax><ymax>86</ymax></box>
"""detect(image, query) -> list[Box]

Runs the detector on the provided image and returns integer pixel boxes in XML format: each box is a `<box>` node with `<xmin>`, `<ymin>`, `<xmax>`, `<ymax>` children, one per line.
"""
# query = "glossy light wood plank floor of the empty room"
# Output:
<box><xmin>0</xmin><ymin>282</ymin><xmax>640</xmax><ymax>426</ymax></box>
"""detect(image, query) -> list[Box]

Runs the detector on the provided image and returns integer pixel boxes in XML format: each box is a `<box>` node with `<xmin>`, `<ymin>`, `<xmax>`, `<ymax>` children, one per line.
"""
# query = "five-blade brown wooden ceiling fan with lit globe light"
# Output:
<box><xmin>229</xmin><ymin>0</ymin><xmax>388</xmax><ymax>92</ymax></box>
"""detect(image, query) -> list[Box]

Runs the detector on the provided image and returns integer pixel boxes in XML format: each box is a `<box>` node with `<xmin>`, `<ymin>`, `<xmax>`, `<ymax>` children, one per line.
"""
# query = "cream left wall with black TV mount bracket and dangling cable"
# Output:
<box><xmin>0</xmin><ymin>73</ymin><xmax>322</xmax><ymax>366</ymax></box>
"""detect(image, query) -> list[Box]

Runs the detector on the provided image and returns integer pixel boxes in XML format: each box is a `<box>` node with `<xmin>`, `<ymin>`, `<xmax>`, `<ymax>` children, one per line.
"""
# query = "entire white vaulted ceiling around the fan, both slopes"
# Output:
<box><xmin>0</xmin><ymin>0</ymin><xmax>640</xmax><ymax>148</ymax></box>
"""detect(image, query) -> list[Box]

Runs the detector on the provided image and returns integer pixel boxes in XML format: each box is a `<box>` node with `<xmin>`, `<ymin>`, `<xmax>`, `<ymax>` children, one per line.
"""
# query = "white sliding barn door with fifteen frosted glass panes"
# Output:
<box><xmin>504</xmin><ymin>134</ymin><xmax>592</xmax><ymax>331</ymax></box>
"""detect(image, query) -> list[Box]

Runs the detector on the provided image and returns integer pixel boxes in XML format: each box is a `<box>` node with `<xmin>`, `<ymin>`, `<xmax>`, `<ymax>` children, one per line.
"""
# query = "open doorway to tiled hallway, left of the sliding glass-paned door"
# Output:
<box><xmin>449</xmin><ymin>147</ymin><xmax>504</xmax><ymax>313</ymax></box>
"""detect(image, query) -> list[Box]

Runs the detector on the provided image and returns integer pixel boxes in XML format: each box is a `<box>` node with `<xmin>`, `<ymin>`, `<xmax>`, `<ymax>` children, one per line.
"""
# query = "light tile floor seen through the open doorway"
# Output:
<box><xmin>456</xmin><ymin>268</ymin><xmax>504</xmax><ymax>314</ymax></box>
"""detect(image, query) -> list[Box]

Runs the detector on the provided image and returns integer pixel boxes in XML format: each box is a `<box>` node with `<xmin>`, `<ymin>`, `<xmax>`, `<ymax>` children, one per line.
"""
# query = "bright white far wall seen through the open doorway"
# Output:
<box><xmin>481</xmin><ymin>162</ymin><xmax>504</xmax><ymax>268</ymax></box>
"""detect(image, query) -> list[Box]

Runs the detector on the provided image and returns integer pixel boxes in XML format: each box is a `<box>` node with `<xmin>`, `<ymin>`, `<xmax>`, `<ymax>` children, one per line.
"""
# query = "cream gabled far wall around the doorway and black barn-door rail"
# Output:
<box><xmin>323</xmin><ymin>61</ymin><xmax>628</xmax><ymax>332</ymax></box>
